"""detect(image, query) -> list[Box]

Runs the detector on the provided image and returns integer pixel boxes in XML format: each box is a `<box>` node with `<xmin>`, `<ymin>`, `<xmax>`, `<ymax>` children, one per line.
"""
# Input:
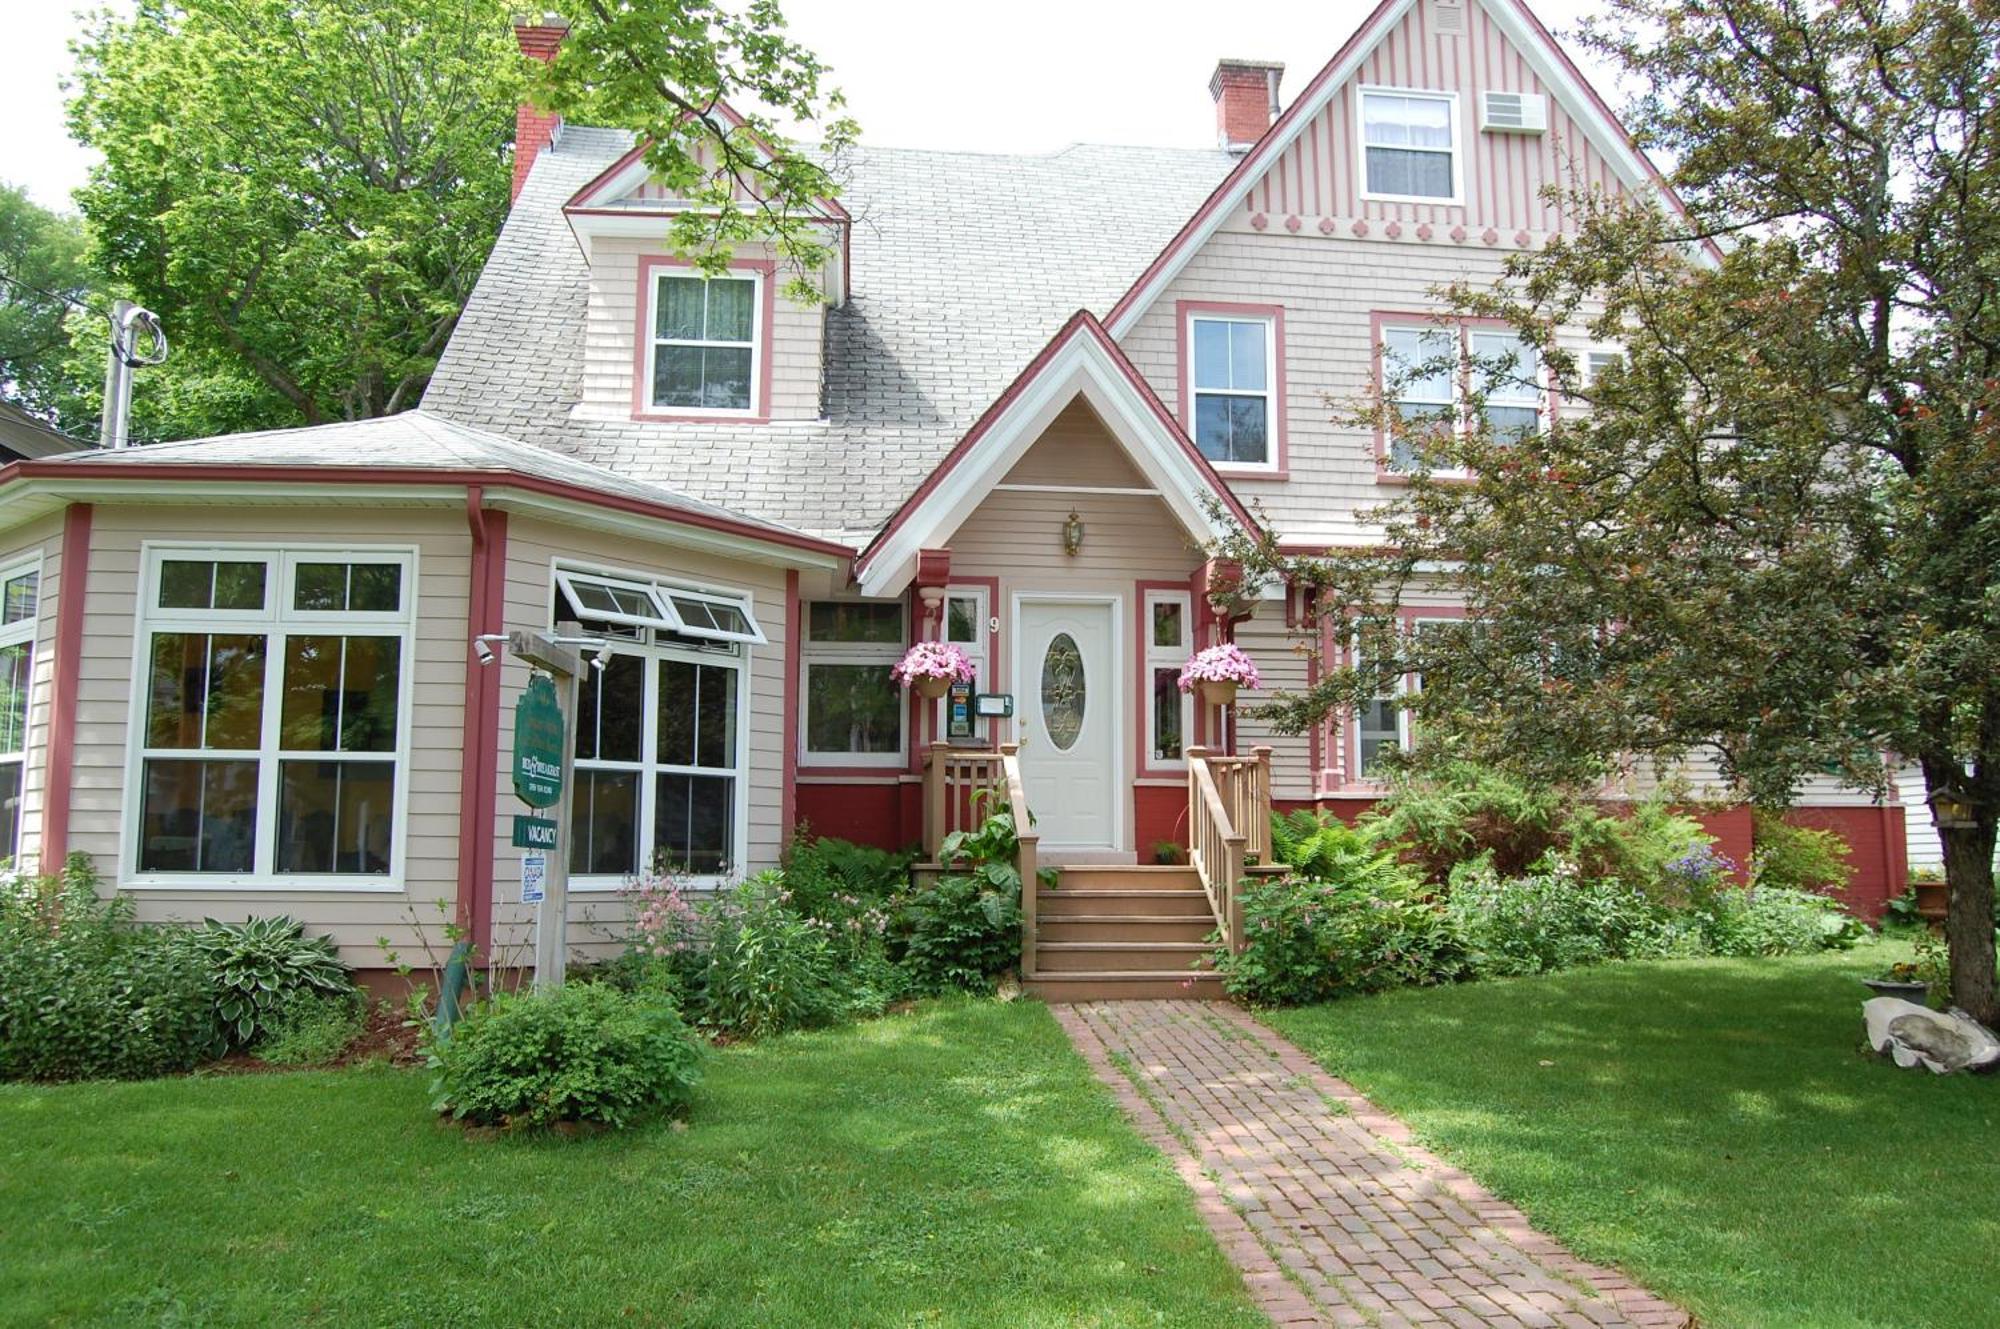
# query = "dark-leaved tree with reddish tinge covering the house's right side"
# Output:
<box><xmin>1230</xmin><ymin>0</ymin><xmax>2000</xmax><ymax>1023</ymax></box>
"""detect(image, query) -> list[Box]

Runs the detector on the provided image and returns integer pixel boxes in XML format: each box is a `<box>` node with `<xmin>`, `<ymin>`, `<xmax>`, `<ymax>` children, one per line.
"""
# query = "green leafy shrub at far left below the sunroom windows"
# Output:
<box><xmin>0</xmin><ymin>855</ymin><xmax>222</xmax><ymax>1081</ymax></box>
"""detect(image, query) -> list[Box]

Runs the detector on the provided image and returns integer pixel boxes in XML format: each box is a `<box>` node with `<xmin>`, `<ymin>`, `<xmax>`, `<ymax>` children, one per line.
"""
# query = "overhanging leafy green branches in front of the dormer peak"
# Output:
<box><xmin>530</xmin><ymin>0</ymin><xmax>858</xmax><ymax>304</ymax></box>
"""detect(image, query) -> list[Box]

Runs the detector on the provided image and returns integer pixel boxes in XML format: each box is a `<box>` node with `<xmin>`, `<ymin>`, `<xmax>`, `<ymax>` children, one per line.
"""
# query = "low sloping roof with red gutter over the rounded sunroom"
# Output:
<box><xmin>0</xmin><ymin>410</ymin><xmax>850</xmax><ymax>566</ymax></box>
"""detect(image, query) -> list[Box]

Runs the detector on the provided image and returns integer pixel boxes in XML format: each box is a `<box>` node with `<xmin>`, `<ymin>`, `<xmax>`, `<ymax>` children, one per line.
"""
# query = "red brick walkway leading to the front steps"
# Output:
<box><xmin>1054</xmin><ymin>1001</ymin><xmax>1692</xmax><ymax>1329</ymax></box>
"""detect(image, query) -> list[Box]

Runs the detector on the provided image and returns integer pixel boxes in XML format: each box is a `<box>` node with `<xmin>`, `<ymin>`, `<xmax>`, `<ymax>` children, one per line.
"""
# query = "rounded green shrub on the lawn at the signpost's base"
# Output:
<box><xmin>426</xmin><ymin>983</ymin><xmax>702</xmax><ymax>1127</ymax></box>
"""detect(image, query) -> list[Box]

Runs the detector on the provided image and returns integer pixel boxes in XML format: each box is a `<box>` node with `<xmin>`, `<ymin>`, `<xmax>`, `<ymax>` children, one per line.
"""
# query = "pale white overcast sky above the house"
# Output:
<box><xmin>0</xmin><ymin>0</ymin><xmax>1620</xmax><ymax>208</ymax></box>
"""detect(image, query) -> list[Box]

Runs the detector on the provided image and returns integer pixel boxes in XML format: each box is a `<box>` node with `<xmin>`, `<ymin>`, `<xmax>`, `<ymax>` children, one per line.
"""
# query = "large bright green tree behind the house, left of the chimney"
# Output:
<box><xmin>70</xmin><ymin>0</ymin><xmax>520</xmax><ymax>422</ymax></box>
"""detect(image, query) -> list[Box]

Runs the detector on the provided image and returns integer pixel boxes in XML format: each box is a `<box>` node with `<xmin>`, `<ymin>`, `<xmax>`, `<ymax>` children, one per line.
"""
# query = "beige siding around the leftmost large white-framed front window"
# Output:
<box><xmin>70</xmin><ymin>506</ymin><xmax>470</xmax><ymax>967</ymax></box>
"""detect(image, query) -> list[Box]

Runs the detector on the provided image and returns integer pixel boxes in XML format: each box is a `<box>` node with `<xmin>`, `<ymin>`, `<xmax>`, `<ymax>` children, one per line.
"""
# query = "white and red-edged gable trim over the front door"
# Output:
<box><xmin>854</xmin><ymin>310</ymin><xmax>1254</xmax><ymax>594</ymax></box>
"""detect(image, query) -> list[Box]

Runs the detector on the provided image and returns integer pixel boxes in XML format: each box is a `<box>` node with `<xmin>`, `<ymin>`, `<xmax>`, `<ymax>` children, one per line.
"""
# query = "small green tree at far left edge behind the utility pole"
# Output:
<box><xmin>0</xmin><ymin>184</ymin><xmax>92</xmax><ymax>426</ymax></box>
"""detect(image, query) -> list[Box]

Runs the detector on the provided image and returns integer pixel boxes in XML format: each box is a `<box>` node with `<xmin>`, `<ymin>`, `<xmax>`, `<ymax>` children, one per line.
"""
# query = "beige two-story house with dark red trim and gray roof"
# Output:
<box><xmin>0</xmin><ymin>0</ymin><xmax>1902</xmax><ymax>980</ymax></box>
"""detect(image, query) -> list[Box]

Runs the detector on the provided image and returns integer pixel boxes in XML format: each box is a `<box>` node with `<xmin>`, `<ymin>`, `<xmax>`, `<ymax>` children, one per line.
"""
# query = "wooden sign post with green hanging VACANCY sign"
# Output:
<box><xmin>508</xmin><ymin>622</ymin><xmax>584</xmax><ymax>987</ymax></box>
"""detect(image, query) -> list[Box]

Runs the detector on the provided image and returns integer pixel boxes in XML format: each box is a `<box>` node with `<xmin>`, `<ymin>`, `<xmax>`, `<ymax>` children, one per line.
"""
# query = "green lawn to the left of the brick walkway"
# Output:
<box><xmin>0</xmin><ymin>1001</ymin><xmax>1264</xmax><ymax>1327</ymax></box>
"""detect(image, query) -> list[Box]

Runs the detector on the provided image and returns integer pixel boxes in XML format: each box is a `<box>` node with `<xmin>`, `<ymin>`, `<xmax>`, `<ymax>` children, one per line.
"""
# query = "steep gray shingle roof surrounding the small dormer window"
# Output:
<box><xmin>424</xmin><ymin>126</ymin><xmax>1236</xmax><ymax>542</ymax></box>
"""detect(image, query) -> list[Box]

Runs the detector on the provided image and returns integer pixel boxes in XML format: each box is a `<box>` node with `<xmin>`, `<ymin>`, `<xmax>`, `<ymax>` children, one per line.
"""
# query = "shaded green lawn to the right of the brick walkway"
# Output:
<box><xmin>1268</xmin><ymin>943</ymin><xmax>2000</xmax><ymax>1329</ymax></box>
